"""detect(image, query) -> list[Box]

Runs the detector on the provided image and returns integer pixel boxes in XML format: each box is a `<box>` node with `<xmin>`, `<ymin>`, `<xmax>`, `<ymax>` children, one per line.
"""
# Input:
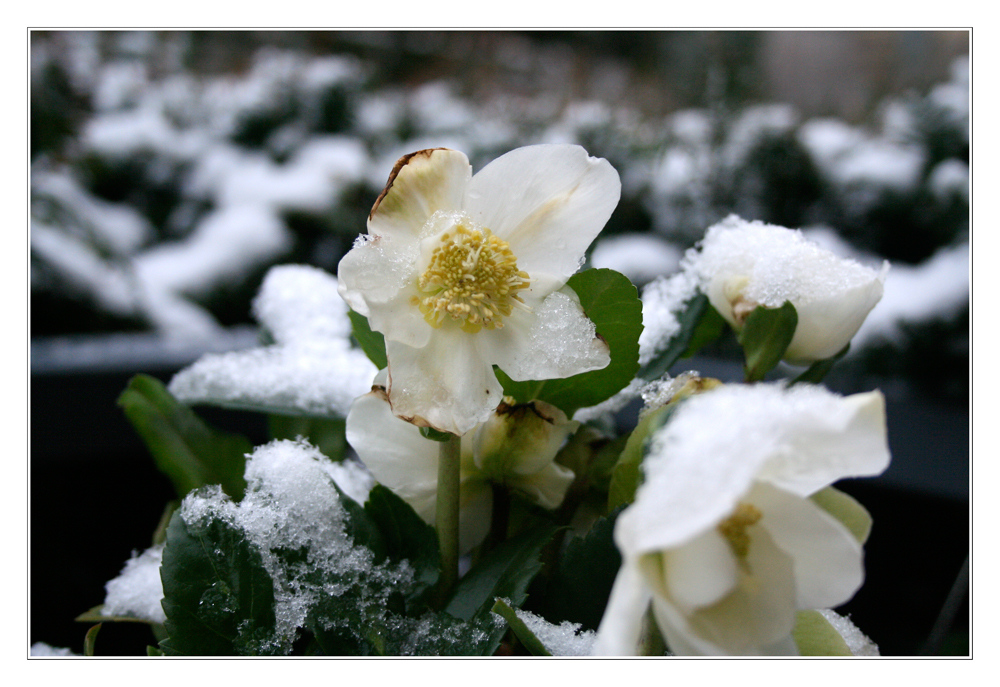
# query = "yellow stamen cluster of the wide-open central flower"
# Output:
<box><xmin>413</xmin><ymin>222</ymin><xmax>529</xmax><ymax>334</ymax></box>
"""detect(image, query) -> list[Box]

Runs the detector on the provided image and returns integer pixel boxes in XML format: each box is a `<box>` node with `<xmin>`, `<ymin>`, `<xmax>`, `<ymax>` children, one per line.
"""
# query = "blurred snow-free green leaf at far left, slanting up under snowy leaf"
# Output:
<box><xmin>118</xmin><ymin>375</ymin><xmax>253</xmax><ymax>499</ymax></box>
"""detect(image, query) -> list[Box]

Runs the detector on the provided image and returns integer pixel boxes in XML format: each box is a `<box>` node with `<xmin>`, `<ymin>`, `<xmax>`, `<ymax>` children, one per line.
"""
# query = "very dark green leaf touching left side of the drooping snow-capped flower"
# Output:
<box><xmin>541</xmin><ymin>508</ymin><xmax>622</xmax><ymax>630</ymax></box>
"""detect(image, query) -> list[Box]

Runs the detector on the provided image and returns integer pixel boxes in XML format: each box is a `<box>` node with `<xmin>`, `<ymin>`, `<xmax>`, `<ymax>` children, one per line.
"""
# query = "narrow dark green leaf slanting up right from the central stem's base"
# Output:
<box><xmin>444</xmin><ymin>524</ymin><xmax>557</xmax><ymax>620</ymax></box>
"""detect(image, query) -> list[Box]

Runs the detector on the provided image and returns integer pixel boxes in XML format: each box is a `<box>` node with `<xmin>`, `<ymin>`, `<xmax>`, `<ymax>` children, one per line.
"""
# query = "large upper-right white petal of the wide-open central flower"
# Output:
<box><xmin>464</xmin><ymin>144</ymin><xmax>621</xmax><ymax>282</ymax></box>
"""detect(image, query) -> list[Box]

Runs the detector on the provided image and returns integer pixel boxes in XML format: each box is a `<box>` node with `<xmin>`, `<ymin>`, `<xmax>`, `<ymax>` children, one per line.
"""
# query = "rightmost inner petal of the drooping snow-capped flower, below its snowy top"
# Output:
<box><xmin>749</xmin><ymin>484</ymin><xmax>865</xmax><ymax>609</ymax></box>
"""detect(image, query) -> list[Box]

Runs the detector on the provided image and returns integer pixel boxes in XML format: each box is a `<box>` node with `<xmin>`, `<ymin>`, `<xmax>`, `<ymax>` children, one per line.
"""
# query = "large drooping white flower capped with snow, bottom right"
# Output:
<box><xmin>594</xmin><ymin>384</ymin><xmax>889</xmax><ymax>655</ymax></box>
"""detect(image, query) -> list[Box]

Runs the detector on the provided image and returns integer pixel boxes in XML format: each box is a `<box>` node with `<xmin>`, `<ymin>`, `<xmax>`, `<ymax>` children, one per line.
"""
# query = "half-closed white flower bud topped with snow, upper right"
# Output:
<box><xmin>687</xmin><ymin>215</ymin><xmax>889</xmax><ymax>364</ymax></box>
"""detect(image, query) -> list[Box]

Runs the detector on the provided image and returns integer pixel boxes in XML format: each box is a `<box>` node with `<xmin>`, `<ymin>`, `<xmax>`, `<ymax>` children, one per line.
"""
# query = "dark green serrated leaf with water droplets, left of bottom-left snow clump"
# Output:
<box><xmin>160</xmin><ymin>513</ymin><xmax>282</xmax><ymax>656</ymax></box>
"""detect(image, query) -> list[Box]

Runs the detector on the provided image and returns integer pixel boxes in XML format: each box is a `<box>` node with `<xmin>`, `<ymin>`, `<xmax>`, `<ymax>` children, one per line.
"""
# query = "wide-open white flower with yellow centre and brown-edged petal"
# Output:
<box><xmin>338</xmin><ymin>145</ymin><xmax>621</xmax><ymax>435</ymax></box>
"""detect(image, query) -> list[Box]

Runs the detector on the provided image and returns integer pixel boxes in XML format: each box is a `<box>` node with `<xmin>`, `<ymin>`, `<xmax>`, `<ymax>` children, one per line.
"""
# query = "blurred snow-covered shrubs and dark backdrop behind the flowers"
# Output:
<box><xmin>30</xmin><ymin>32</ymin><xmax>970</xmax><ymax>646</ymax></box>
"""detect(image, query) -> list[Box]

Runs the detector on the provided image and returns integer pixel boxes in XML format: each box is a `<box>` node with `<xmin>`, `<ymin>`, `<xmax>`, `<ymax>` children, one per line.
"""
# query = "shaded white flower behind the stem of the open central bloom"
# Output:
<box><xmin>347</xmin><ymin>370</ymin><xmax>580</xmax><ymax>552</ymax></box>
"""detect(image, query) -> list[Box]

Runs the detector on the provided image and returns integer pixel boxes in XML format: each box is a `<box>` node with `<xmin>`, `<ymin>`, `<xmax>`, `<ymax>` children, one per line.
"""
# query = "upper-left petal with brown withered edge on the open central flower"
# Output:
<box><xmin>368</xmin><ymin>148</ymin><xmax>472</xmax><ymax>240</ymax></box>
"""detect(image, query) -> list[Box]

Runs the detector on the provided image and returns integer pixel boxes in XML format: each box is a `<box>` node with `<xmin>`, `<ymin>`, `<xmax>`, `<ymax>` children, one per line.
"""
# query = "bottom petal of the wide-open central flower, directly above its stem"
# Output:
<box><xmin>386</xmin><ymin>327</ymin><xmax>503</xmax><ymax>435</ymax></box>
